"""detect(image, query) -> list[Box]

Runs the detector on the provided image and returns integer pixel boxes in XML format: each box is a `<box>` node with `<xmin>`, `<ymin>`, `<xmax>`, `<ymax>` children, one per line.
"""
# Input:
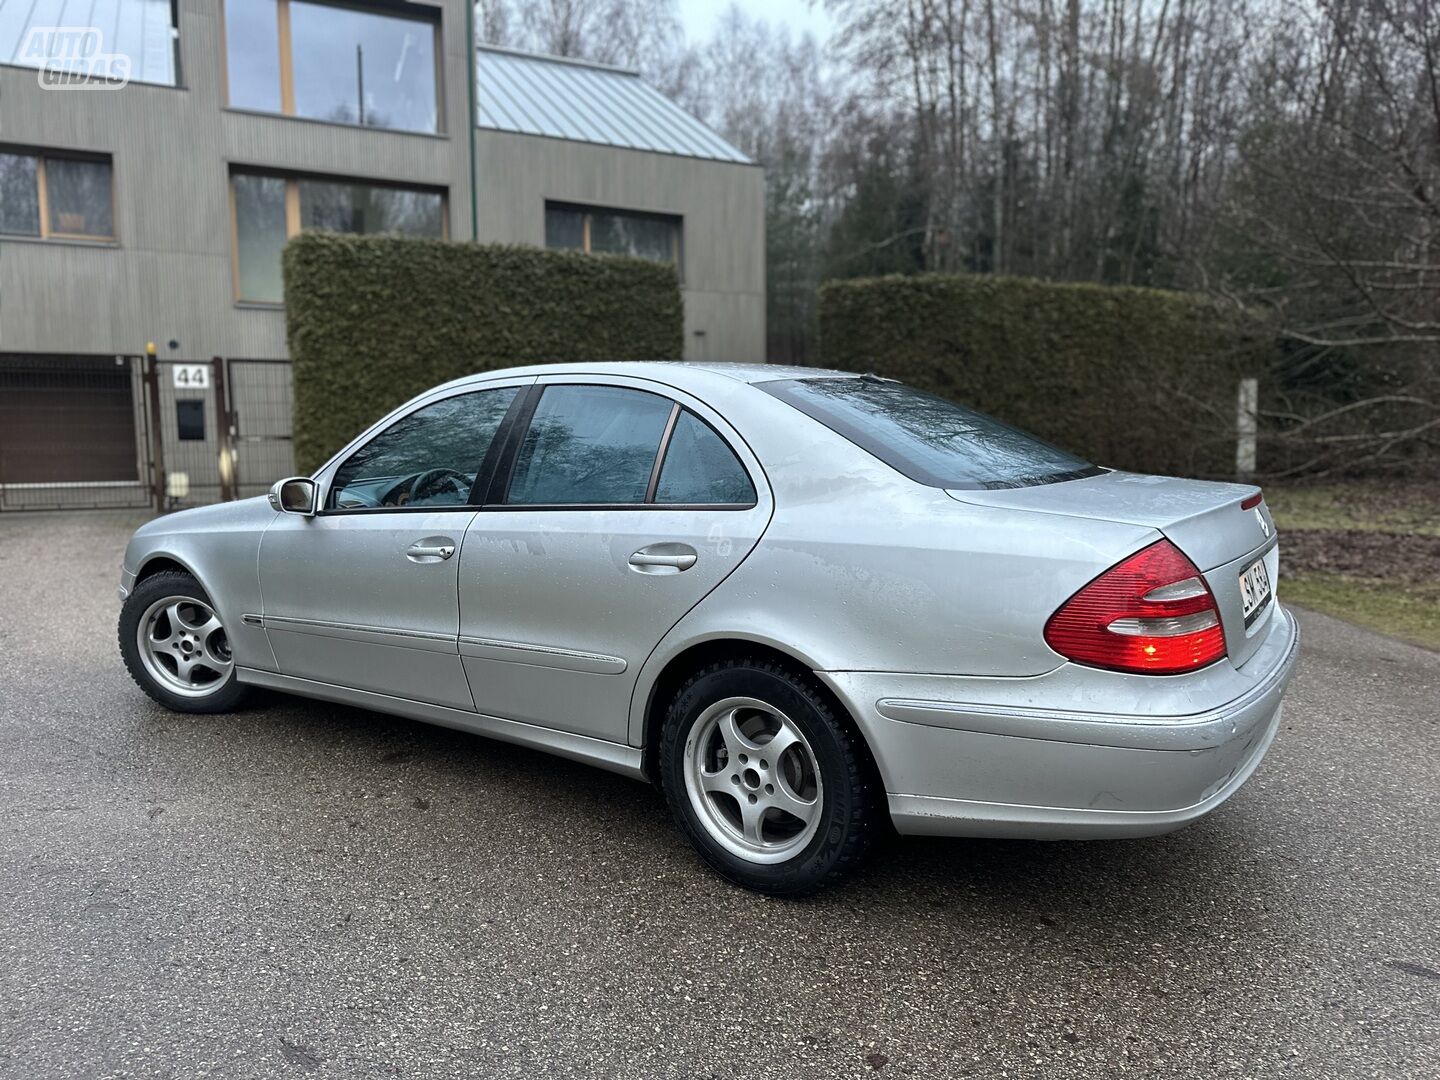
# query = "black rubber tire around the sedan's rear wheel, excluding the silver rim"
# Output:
<box><xmin>658</xmin><ymin>658</ymin><xmax>886</xmax><ymax>897</ymax></box>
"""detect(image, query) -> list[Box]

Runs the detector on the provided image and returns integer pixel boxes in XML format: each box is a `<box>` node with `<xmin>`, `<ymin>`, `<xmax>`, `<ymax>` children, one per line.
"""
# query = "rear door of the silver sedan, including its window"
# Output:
<box><xmin>459</xmin><ymin>376</ymin><xmax>770</xmax><ymax>743</ymax></box>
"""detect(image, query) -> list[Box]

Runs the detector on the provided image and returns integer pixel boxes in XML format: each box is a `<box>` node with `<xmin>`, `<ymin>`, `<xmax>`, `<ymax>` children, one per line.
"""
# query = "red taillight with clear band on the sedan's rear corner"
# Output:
<box><xmin>1045</xmin><ymin>540</ymin><xmax>1225</xmax><ymax>675</ymax></box>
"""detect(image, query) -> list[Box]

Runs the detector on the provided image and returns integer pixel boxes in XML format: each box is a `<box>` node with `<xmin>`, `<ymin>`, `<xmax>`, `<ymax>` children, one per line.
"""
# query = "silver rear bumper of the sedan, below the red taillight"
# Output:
<box><xmin>819</xmin><ymin>609</ymin><xmax>1299</xmax><ymax>840</ymax></box>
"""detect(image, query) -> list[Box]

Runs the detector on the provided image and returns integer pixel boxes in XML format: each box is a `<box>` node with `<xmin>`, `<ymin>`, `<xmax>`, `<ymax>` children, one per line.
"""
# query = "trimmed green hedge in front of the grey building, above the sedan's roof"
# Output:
<box><xmin>285</xmin><ymin>232</ymin><xmax>684</xmax><ymax>472</ymax></box>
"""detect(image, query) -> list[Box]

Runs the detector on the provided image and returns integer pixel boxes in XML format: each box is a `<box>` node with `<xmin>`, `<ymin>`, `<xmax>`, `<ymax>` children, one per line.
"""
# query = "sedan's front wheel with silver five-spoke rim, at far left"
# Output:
<box><xmin>120</xmin><ymin>570</ymin><xmax>246</xmax><ymax>713</ymax></box>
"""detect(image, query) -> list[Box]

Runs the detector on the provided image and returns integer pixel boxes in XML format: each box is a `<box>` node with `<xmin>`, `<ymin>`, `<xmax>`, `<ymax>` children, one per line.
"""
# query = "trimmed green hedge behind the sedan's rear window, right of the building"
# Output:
<box><xmin>819</xmin><ymin>274</ymin><xmax>1267</xmax><ymax>477</ymax></box>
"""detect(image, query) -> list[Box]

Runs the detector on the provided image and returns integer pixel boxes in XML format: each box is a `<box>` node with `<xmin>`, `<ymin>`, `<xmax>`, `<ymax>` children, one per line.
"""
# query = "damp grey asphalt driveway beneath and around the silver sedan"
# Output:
<box><xmin>0</xmin><ymin>514</ymin><xmax>1440</xmax><ymax>1080</ymax></box>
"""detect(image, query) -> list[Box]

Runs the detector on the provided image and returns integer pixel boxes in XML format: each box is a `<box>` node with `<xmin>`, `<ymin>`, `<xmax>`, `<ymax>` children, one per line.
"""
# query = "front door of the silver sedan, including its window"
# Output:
<box><xmin>259</xmin><ymin>380</ymin><xmax>533</xmax><ymax>710</ymax></box>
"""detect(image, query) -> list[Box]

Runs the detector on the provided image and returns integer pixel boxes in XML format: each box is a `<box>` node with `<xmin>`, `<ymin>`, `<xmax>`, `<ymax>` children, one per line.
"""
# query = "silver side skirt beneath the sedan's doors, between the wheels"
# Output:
<box><xmin>236</xmin><ymin>668</ymin><xmax>647</xmax><ymax>780</ymax></box>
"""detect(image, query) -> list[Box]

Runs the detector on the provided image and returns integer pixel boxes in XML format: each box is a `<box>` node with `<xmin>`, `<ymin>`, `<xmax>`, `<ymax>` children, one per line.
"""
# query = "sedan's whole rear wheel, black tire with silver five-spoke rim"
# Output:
<box><xmin>660</xmin><ymin>660</ymin><xmax>880</xmax><ymax>896</ymax></box>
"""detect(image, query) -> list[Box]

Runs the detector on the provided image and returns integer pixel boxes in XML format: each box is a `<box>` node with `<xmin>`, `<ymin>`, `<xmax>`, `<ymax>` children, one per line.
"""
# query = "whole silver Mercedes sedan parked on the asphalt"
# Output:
<box><xmin>120</xmin><ymin>364</ymin><xmax>1297</xmax><ymax>894</ymax></box>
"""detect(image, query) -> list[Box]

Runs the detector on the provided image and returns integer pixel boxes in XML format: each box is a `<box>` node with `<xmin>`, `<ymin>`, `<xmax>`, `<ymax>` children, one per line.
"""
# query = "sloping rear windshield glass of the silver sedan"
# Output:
<box><xmin>757</xmin><ymin>376</ymin><xmax>1103</xmax><ymax>491</ymax></box>
